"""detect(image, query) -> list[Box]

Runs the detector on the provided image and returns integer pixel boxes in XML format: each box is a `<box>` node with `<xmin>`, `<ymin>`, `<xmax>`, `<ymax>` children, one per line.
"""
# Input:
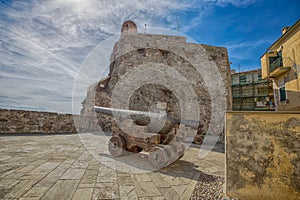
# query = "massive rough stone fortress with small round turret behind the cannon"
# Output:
<box><xmin>81</xmin><ymin>20</ymin><xmax>231</xmax><ymax>143</ymax></box>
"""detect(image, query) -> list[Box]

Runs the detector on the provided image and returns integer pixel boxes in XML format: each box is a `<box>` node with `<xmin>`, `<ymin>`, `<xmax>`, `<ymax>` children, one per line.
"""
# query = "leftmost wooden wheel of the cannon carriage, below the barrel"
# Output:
<box><xmin>108</xmin><ymin>136</ymin><xmax>126</xmax><ymax>157</ymax></box>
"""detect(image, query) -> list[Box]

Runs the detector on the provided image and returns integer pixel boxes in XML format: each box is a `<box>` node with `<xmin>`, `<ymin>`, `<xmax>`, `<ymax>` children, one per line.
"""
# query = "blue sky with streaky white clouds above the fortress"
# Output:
<box><xmin>0</xmin><ymin>0</ymin><xmax>300</xmax><ymax>113</ymax></box>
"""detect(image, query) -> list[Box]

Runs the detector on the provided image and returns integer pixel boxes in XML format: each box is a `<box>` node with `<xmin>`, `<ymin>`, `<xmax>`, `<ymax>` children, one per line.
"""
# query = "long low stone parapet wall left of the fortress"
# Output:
<box><xmin>0</xmin><ymin>109</ymin><xmax>98</xmax><ymax>134</ymax></box>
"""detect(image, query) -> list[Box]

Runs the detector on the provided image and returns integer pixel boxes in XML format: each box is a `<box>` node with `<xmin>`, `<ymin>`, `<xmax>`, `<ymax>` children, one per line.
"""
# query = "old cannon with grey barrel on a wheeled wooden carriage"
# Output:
<box><xmin>94</xmin><ymin>106</ymin><xmax>198</xmax><ymax>169</ymax></box>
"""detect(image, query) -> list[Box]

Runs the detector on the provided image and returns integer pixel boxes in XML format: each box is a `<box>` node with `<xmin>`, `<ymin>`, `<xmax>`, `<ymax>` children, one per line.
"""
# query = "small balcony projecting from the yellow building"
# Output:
<box><xmin>269</xmin><ymin>57</ymin><xmax>293</xmax><ymax>78</ymax></box>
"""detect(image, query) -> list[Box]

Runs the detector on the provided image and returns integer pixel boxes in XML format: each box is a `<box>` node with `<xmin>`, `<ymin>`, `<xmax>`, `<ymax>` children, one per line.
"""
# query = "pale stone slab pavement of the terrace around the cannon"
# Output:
<box><xmin>0</xmin><ymin>133</ymin><xmax>225</xmax><ymax>200</ymax></box>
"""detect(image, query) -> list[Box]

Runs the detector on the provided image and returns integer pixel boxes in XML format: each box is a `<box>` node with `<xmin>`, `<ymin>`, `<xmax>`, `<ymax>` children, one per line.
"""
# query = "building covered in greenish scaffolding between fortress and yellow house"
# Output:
<box><xmin>231</xmin><ymin>69</ymin><xmax>274</xmax><ymax>111</ymax></box>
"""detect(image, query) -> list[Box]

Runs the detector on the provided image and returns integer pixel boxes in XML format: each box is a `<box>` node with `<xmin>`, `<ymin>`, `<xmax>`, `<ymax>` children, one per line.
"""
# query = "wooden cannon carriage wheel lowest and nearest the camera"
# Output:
<box><xmin>149</xmin><ymin>147</ymin><xmax>169</xmax><ymax>169</ymax></box>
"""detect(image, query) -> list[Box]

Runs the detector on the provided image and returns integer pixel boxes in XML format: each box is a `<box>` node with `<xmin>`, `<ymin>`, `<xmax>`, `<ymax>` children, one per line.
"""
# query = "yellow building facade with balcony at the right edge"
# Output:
<box><xmin>261</xmin><ymin>20</ymin><xmax>300</xmax><ymax>111</ymax></box>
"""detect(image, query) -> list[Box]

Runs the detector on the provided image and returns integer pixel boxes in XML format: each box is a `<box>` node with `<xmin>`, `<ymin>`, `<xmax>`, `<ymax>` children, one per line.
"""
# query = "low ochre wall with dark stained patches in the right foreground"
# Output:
<box><xmin>226</xmin><ymin>112</ymin><xmax>300</xmax><ymax>200</ymax></box>
